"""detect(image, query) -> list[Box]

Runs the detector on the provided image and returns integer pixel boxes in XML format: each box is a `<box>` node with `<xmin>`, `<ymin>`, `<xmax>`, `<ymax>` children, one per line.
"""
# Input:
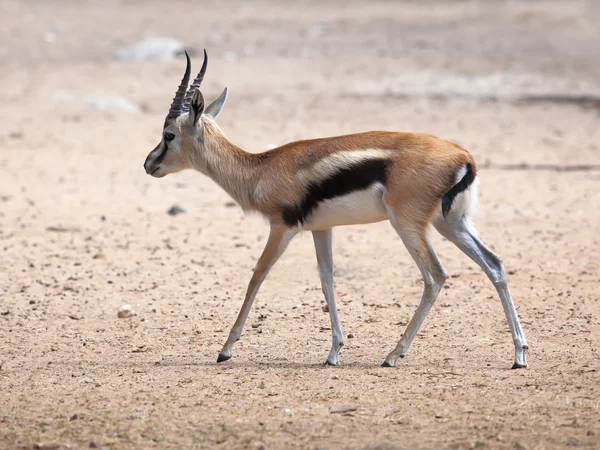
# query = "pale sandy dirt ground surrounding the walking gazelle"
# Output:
<box><xmin>0</xmin><ymin>0</ymin><xmax>600</xmax><ymax>450</ymax></box>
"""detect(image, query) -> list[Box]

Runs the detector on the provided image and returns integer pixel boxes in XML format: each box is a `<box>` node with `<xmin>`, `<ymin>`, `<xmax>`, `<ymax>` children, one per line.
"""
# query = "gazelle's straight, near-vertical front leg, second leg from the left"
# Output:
<box><xmin>313</xmin><ymin>229</ymin><xmax>344</xmax><ymax>366</ymax></box>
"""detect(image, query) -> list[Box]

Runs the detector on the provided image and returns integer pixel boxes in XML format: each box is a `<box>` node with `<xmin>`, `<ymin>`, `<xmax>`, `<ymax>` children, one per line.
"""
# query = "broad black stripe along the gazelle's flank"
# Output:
<box><xmin>283</xmin><ymin>159</ymin><xmax>390</xmax><ymax>226</ymax></box>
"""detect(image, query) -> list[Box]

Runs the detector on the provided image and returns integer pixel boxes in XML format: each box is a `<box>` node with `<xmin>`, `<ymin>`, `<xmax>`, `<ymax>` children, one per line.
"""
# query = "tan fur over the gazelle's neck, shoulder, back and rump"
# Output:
<box><xmin>186</xmin><ymin>118</ymin><xmax>475</xmax><ymax>226</ymax></box>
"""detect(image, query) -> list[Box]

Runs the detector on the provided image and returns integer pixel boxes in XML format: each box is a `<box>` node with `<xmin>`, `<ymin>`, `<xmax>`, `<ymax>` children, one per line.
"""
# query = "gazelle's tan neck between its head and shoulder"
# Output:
<box><xmin>193</xmin><ymin>117</ymin><xmax>260</xmax><ymax>211</ymax></box>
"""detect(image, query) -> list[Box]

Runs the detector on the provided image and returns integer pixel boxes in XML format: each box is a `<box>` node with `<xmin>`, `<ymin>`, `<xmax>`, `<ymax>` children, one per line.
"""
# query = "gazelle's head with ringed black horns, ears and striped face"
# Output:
<box><xmin>144</xmin><ymin>50</ymin><xmax>227</xmax><ymax>178</ymax></box>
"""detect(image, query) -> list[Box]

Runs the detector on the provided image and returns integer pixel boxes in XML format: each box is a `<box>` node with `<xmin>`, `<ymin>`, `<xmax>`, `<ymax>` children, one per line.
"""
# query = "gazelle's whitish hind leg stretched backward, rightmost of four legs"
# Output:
<box><xmin>434</xmin><ymin>214</ymin><xmax>528</xmax><ymax>369</ymax></box>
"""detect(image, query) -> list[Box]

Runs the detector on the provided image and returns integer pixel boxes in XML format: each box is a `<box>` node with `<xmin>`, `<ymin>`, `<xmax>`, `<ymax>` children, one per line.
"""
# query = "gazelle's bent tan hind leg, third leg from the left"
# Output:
<box><xmin>382</xmin><ymin>210</ymin><xmax>448</xmax><ymax>367</ymax></box>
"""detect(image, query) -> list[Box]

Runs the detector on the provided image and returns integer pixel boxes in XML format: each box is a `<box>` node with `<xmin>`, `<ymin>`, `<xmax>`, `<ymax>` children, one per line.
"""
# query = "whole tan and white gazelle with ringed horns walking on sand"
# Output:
<box><xmin>144</xmin><ymin>51</ymin><xmax>528</xmax><ymax>368</ymax></box>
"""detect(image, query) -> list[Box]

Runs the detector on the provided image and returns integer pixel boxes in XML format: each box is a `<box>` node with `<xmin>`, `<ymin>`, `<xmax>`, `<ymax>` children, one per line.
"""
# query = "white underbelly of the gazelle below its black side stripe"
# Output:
<box><xmin>303</xmin><ymin>185</ymin><xmax>388</xmax><ymax>230</ymax></box>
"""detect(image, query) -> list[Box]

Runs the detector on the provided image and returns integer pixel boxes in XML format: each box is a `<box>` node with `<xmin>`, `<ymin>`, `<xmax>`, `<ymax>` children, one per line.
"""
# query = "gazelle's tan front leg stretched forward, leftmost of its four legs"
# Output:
<box><xmin>217</xmin><ymin>224</ymin><xmax>297</xmax><ymax>363</ymax></box>
